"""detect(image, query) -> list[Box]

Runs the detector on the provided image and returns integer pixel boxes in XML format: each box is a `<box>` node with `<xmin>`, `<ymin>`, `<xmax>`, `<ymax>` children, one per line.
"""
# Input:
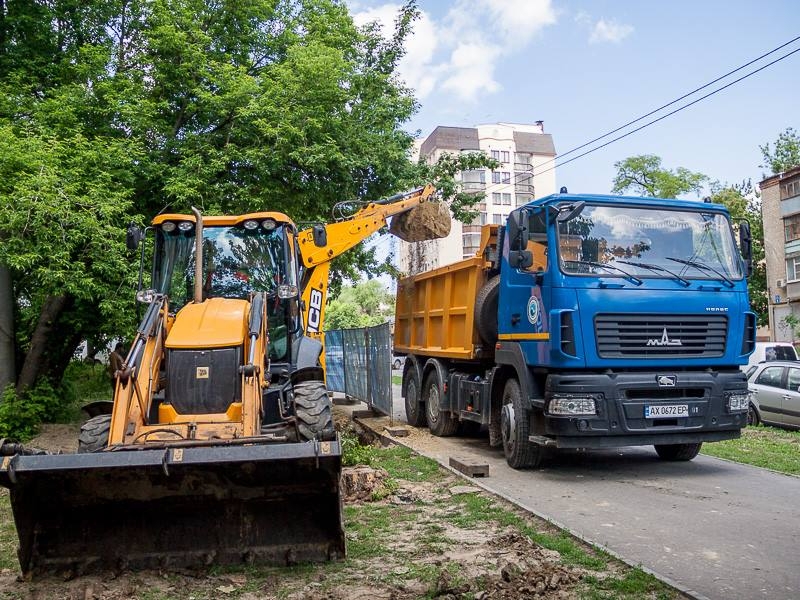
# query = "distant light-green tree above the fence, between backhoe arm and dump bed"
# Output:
<box><xmin>325</xmin><ymin>279</ymin><xmax>394</xmax><ymax>329</ymax></box>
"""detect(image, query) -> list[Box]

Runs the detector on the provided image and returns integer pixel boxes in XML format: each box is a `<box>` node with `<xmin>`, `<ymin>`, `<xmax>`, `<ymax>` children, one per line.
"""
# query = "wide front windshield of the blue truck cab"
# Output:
<box><xmin>558</xmin><ymin>205</ymin><xmax>742</xmax><ymax>285</ymax></box>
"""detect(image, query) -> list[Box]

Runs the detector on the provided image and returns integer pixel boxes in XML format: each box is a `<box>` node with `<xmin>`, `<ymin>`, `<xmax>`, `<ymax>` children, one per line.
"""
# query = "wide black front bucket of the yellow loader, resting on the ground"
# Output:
<box><xmin>0</xmin><ymin>440</ymin><xmax>345</xmax><ymax>577</ymax></box>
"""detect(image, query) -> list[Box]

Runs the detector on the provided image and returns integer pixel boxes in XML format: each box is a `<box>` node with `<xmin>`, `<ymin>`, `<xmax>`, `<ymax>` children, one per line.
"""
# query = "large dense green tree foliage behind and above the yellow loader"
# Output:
<box><xmin>0</xmin><ymin>0</ymin><xmax>432</xmax><ymax>412</ymax></box>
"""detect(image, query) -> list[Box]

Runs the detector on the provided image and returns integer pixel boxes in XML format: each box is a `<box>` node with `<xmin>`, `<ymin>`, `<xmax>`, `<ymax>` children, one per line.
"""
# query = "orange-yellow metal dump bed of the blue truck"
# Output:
<box><xmin>394</xmin><ymin>256</ymin><xmax>489</xmax><ymax>360</ymax></box>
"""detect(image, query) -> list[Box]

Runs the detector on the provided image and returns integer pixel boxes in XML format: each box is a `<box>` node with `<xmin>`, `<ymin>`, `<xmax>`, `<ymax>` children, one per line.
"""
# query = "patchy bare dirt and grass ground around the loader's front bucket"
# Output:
<box><xmin>0</xmin><ymin>417</ymin><xmax>676</xmax><ymax>600</ymax></box>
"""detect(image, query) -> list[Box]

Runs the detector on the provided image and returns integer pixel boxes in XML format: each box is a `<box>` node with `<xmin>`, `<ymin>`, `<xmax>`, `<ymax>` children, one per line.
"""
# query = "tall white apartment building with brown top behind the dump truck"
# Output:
<box><xmin>399</xmin><ymin>121</ymin><xmax>556</xmax><ymax>274</ymax></box>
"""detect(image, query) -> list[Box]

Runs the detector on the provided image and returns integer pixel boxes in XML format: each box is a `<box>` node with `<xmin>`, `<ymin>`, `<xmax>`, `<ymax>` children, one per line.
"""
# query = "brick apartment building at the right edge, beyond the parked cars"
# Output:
<box><xmin>759</xmin><ymin>166</ymin><xmax>800</xmax><ymax>342</ymax></box>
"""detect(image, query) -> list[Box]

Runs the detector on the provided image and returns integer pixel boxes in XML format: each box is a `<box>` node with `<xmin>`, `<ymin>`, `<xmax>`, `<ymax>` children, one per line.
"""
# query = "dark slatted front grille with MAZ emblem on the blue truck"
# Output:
<box><xmin>594</xmin><ymin>314</ymin><xmax>728</xmax><ymax>358</ymax></box>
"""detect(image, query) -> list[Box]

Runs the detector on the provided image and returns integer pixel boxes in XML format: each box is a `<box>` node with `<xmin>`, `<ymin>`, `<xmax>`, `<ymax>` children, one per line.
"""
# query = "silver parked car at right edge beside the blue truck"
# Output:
<box><xmin>747</xmin><ymin>361</ymin><xmax>800</xmax><ymax>429</ymax></box>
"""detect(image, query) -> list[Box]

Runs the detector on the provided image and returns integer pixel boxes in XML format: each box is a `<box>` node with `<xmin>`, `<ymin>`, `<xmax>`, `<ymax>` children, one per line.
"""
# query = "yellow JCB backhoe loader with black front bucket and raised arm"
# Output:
<box><xmin>0</xmin><ymin>186</ymin><xmax>449</xmax><ymax>576</ymax></box>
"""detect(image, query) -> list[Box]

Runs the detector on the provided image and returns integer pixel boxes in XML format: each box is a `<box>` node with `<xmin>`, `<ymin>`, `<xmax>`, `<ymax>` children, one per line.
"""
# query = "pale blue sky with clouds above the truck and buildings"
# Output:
<box><xmin>348</xmin><ymin>0</ymin><xmax>800</xmax><ymax>199</ymax></box>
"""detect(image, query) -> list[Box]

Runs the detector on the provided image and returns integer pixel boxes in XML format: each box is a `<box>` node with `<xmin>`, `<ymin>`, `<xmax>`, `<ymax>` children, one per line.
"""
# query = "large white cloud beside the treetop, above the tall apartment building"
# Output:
<box><xmin>350</xmin><ymin>0</ymin><xmax>557</xmax><ymax>102</ymax></box>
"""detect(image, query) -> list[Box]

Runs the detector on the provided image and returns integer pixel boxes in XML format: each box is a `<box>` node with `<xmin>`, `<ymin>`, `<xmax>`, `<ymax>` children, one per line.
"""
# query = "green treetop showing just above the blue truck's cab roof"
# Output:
<box><xmin>611</xmin><ymin>154</ymin><xmax>708</xmax><ymax>198</ymax></box>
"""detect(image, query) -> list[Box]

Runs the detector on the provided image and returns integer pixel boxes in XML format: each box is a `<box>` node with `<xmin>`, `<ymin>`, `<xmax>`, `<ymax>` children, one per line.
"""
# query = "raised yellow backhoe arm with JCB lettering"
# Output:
<box><xmin>298</xmin><ymin>184</ymin><xmax>436</xmax><ymax>338</ymax></box>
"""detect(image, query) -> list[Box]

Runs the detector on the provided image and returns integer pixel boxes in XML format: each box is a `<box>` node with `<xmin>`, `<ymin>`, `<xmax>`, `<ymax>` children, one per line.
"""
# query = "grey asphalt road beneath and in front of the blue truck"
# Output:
<box><xmin>364</xmin><ymin>386</ymin><xmax>800</xmax><ymax>600</ymax></box>
